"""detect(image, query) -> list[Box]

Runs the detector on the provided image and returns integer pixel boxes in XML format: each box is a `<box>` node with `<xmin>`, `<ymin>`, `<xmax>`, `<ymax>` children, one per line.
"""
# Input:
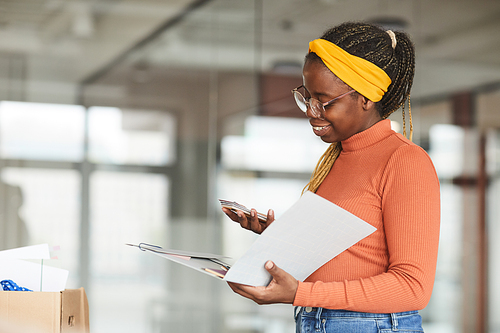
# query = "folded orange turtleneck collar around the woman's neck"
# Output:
<box><xmin>342</xmin><ymin>119</ymin><xmax>395</xmax><ymax>152</ymax></box>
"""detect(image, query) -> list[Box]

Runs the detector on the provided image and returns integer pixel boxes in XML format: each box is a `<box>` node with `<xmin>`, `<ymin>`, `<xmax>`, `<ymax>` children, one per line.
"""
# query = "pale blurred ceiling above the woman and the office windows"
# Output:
<box><xmin>0</xmin><ymin>0</ymin><xmax>500</xmax><ymax>101</ymax></box>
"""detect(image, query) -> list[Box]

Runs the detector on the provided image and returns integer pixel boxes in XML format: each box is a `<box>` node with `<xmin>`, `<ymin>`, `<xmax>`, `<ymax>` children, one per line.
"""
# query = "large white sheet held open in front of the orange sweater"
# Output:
<box><xmin>224</xmin><ymin>192</ymin><xmax>376</xmax><ymax>286</ymax></box>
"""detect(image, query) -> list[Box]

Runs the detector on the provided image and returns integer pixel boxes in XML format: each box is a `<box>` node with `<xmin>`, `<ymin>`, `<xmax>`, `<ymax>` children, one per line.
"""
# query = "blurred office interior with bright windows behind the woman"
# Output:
<box><xmin>0</xmin><ymin>0</ymin><xmax>500</xmax><ymax>333</ymax></box>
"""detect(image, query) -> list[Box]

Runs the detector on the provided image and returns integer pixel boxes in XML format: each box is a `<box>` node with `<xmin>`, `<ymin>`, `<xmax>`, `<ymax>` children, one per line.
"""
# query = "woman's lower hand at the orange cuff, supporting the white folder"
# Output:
<box><xmin>228</xmin><ymin>261</ymin><xmax>299</xmax><ymax>305</ymax></box>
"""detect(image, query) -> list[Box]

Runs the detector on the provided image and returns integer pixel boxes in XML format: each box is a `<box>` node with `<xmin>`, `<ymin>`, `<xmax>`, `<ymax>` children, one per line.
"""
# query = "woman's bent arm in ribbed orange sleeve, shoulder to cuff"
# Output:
<box><xmin>294</xmin><ymin>146</ymin><xmax>440</xmax><ymax>313</ymax></box>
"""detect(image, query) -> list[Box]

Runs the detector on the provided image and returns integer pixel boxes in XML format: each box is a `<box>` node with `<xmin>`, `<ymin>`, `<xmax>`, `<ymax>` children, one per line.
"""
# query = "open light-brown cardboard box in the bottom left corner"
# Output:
<box><xmin>0</xmin><ymin>288</ymin><xmax>89</xmax><ymax>333</ymax></box>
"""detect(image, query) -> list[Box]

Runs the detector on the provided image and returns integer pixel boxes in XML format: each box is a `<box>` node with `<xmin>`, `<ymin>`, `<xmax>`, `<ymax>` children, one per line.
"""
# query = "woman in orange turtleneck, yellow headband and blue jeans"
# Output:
<box><xmin>224</xmin><ymin>23</ymin><xmax>440</xmax><ymax>333</ymax></box>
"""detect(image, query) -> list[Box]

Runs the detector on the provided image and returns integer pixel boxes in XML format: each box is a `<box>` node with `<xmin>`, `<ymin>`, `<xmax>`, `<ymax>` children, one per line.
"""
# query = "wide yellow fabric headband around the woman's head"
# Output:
<box><xmin>309</xmin><ymin>39</ymin><xmax>391</xmax><ymax>102</ymax></box>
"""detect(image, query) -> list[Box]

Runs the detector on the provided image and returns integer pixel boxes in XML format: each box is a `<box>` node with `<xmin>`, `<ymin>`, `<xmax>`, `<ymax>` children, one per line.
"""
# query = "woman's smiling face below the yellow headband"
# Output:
<box><xmin>302</xmin><ymin>60</ymin><xmax>382</xmax><ymax>143</ymax></box>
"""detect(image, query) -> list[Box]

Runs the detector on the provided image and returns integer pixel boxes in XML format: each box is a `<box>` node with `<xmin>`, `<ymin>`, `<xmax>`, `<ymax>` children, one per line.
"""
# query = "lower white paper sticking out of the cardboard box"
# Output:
<box><xmin>0</xmin><ymin>259</ymin><xmax>69</xmax><ymax>292</ymax></box>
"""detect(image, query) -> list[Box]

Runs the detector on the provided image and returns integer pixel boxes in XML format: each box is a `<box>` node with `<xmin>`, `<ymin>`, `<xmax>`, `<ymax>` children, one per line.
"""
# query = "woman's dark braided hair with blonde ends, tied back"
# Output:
<box><xmin>304</xmin><ymin>22</ymin><xmax>415</xmax><ymax>192</ymax></box>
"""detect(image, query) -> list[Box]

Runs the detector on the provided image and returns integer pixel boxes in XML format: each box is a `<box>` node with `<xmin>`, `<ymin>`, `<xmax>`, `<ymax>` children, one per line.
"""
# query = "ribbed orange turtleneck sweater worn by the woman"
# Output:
<box><xmin>294</xmin><ymin>119</ymin><xmax>440</xmax><ymax>313</ymax></box>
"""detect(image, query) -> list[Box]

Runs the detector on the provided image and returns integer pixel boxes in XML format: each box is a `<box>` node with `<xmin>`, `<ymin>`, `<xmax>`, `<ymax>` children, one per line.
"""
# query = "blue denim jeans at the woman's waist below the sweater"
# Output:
<box><xmin>295</xmin><ymin>307</ymin><xmax>424</xmax><ymax>333</ymax></box>
